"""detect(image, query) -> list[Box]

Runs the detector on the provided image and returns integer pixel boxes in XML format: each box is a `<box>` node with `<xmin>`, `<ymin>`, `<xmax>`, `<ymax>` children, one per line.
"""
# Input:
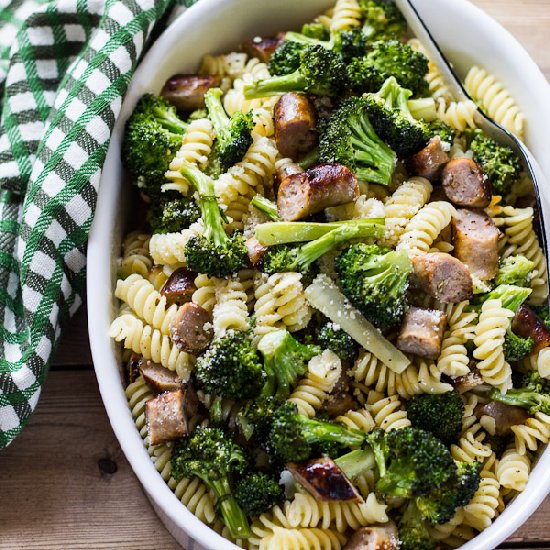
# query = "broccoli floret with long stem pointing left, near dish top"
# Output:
<box><xmin>243</xmin><ymin>45</ymin><xmax>347</xmax><ymax>99</ymax></box>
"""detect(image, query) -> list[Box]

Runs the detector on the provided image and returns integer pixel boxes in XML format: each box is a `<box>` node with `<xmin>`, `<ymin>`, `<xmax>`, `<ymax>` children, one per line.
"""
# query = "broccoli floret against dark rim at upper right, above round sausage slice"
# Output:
<box><xmin>470</xmin><ymin>131</ymin><xmax>521</xmax><ymax>195</ymax></box>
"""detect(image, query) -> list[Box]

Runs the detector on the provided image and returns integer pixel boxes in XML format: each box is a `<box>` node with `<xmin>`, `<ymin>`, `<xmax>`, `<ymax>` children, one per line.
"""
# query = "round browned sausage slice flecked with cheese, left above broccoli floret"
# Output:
<box><xmin>170</xmin><ymin>302</ymin><xmax>214</xmax><ymax>354</ymax></box>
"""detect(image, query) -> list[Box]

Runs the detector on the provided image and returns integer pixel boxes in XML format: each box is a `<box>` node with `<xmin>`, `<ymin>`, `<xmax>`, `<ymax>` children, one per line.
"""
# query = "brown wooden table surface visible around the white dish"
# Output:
<box><xmin>0</xmin><ymin>0</ymin><xmax>550</xmax><ymax>550</ymax></box>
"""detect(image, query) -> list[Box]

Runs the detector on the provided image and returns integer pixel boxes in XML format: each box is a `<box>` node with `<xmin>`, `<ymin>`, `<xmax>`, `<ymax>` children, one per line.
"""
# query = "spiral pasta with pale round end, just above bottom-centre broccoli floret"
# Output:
<box><xmin>288</xmin><ymin>350</ymin><xmax>342</xmax><ymax>417</ymax></box>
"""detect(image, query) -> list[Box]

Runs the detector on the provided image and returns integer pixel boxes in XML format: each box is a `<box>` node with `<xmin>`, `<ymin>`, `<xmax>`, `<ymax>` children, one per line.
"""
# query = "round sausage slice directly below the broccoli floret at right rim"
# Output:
<box><xmin>441</xmin><ymin>158</ymin><xmax>493</xmax><ymax>208</ymax></box>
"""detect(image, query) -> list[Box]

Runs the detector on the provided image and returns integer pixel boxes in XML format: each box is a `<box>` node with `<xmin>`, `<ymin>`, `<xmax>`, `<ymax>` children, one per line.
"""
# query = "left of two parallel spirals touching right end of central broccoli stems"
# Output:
<box><xmin>384</xmin><ymin>177</ymin><xmax>432</xmax><ymax>247</ymax></box>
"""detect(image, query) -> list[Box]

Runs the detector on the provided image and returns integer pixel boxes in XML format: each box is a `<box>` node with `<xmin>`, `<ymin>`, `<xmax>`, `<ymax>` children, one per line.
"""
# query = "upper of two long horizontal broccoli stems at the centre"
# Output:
<box><xmin>256</xmin><ymin>218</ymin><xmax>385</xmax><ymax>246</ymax></box>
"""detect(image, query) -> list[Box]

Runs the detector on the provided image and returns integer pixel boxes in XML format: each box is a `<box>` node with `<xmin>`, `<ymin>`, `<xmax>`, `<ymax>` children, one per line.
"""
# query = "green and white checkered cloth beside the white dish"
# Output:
<box><xmin>0</xmin><ymin>0</ymin><xmax>198</xmax><ymax>449</ymax></box>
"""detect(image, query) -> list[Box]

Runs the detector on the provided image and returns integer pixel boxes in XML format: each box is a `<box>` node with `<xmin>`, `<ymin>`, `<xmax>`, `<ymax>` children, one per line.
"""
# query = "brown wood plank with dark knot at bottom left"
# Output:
<box><xmin>0</xmin><ymin>371</ymin><xmax>179</xmax><ymax>550</ymax></box>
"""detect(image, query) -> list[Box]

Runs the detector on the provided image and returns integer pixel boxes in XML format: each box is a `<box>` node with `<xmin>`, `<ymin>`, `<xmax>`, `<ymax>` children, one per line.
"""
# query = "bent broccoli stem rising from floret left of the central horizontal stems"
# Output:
<box><xmin>180</xmin><ymin>164</ymin><xmax>227</xmax><ymax>246</ymax></box>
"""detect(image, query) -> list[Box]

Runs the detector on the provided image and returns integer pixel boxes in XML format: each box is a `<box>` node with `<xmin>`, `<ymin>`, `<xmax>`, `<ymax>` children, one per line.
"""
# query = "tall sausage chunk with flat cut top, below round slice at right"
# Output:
<box><xmin>452</xmin><ymin>208</ymin><xmax>500</xmax><ymax>281</ymax></box>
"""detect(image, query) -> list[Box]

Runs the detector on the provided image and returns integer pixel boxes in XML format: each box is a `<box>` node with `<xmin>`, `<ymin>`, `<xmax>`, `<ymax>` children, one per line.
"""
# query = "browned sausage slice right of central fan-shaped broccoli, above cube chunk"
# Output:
<box><xmin>412</xmin><ymin>252</ymin><xmax>474</xmax><ymax>304</ymax></box>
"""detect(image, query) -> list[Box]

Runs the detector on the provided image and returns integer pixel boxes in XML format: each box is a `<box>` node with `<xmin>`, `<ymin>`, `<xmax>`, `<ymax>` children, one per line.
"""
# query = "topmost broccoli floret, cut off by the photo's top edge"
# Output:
<box><xmin>359</xmin><ymin>0</ymin><xmax>407</xmax><ymax>41</ymax></box>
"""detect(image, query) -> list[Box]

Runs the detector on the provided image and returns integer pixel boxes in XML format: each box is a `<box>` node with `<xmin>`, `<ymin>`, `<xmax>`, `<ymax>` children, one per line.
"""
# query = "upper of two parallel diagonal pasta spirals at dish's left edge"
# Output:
<box><xmin>115</xmin><ymin>273</ymin><xmax>178</xmax><ymax>334</ymax></box>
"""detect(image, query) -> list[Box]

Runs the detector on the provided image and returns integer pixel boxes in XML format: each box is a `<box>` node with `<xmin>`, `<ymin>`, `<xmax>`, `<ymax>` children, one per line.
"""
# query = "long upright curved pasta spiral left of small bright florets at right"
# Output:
<box><xmin>474</xmin><ymin>300</ymin><xmax>514</xmax><ymax>392</ymax></box>
